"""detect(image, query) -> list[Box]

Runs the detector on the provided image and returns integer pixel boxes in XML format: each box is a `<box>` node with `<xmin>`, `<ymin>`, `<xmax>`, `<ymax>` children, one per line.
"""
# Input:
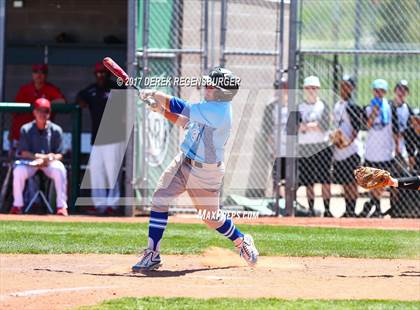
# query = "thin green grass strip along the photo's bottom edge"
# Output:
<box><xmin>80</xmin><ymin>297</ymin><xmax>420</xmax><ymax>310</ymax></box>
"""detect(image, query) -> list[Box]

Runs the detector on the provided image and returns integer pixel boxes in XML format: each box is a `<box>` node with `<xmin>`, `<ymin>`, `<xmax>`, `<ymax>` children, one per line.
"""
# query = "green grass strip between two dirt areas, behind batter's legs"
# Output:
<box><xmin>0</xmin><ymin>221</ymin><xmax>420</xmax><ymax>258</ymax></box>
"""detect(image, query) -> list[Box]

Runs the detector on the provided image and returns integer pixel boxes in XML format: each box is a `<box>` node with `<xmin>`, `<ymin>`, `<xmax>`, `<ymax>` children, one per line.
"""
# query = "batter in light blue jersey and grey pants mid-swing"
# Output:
<box><xmin>132</xmin><ymin>67</ymin><xmax>259</xmax><ymax>272</ymax></box>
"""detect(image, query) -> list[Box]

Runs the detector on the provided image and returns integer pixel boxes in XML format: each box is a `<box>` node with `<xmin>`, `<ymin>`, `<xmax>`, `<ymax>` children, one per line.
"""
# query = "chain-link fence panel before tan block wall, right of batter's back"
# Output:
<box><xmin>220</xmin><ymin>1</ymin><xmax>284</xmax><ymax>199</ymax></box>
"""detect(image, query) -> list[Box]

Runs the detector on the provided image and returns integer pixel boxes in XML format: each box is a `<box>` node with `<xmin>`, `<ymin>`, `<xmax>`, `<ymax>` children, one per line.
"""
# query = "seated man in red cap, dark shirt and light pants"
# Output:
<box><xmin>10</xmin><ymin>98</ymin><xmax>68</xmax><ymax>216</ymax></box>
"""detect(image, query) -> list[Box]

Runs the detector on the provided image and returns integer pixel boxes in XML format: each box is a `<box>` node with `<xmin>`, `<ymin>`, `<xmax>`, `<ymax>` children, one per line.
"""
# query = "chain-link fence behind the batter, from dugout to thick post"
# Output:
<box><xmin>134</xmin><ymin>0</ymin><xmax>286</xmax><ymax>215</ymax></box>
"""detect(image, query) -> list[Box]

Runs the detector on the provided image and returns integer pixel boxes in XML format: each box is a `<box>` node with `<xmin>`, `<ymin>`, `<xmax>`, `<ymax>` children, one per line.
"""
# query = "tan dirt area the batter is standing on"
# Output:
<box><xmin>0</xmin><ymin>248</ymin><xmax>420</xmax><ymax>309</ymax></box>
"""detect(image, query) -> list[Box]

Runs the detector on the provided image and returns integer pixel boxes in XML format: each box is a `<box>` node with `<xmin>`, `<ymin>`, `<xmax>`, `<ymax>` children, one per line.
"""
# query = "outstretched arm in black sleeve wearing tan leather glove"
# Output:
<box><xmin>354</xmin><ymin>167</ymin><xmax>420</xmax><ymax>190</ymax></box>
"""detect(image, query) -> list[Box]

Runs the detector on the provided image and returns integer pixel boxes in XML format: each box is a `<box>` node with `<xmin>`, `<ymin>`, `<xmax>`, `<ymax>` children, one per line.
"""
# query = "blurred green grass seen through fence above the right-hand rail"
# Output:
<box><xmin>299</xmin><ymin>0</ymin><xmax>420</xmax><ymax>48</ymax></box>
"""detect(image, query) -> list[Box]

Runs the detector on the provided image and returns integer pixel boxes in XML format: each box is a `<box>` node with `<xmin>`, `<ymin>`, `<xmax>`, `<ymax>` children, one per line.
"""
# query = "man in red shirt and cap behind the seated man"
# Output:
<box><xmin>10</xmin><ymin>64</ymin><xmax>65</xmax><ymax>148</ymax></box>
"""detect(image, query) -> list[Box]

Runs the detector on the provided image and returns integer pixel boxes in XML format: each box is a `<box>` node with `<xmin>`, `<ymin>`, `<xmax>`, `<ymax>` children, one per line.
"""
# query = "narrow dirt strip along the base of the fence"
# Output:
<box><xmin>0</xmin><ymin>214</ymin><xmax>420</xmax><ymax>230</ymax></box>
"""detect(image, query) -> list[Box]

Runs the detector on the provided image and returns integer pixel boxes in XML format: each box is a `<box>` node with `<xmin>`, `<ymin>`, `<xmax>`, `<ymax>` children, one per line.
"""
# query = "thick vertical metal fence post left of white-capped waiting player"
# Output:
<box><xmin>286</xmin><ymin>1</ymin><xmax>299</xmax><ymax>216</ymax></box>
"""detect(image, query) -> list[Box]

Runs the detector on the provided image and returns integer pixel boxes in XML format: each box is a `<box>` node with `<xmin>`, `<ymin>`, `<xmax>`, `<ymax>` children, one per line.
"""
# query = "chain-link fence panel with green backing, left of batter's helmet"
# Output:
<box><xmin>133</xmin><ymin>0</ymin><xmax>208</xmax><ymax>208</ymax></box>
